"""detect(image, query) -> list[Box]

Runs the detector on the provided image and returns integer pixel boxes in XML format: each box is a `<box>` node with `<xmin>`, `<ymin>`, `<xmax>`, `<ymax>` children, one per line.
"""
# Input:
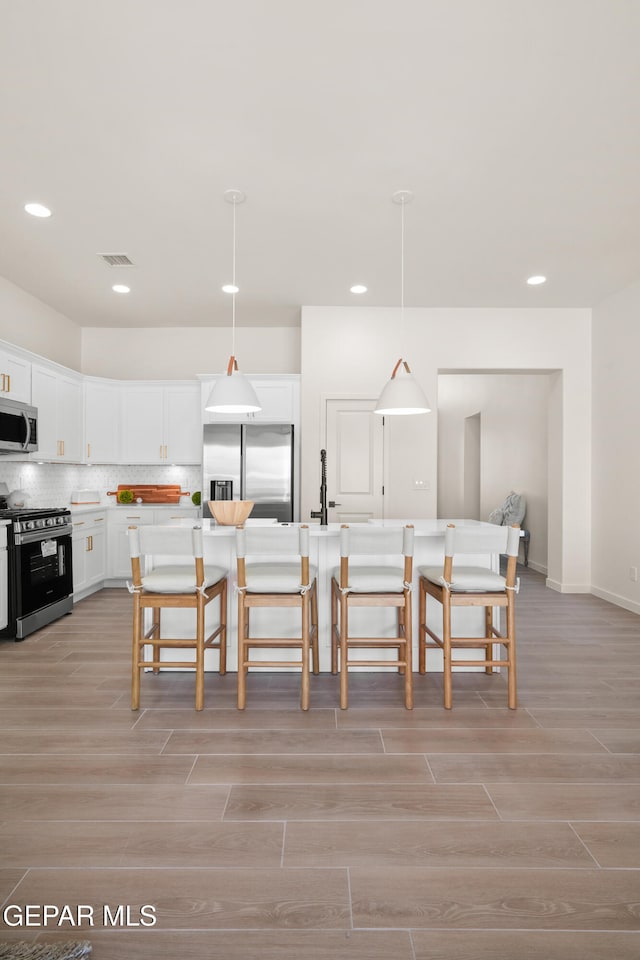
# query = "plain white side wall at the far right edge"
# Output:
<box><xmin>592</xmin><ymin>282</ymin><xmax>640</xmax><ymax>613</ymax></box>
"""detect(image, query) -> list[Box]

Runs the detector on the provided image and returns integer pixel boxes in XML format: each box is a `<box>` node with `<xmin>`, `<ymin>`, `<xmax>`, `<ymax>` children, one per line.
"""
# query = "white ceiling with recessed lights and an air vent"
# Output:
<box><xmin>0</xmin><ymin>0</ymin><xmax>640</xmax><ymax>327</ymax></box>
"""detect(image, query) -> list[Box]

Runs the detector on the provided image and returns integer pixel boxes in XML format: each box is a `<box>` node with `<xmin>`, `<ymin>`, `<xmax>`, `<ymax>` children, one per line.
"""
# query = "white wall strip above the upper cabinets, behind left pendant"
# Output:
<box><xmin>82</xmin><ymin>326</ymin><xmax>300</xmax><ymax>380</ymax></box>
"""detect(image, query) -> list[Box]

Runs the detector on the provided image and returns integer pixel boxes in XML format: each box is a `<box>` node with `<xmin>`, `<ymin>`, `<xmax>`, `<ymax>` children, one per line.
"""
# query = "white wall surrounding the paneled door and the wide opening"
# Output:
<box><xmin>300</xmin><ymin>307</ymin><xmax>591</xmax><ymax>592</ymax></box>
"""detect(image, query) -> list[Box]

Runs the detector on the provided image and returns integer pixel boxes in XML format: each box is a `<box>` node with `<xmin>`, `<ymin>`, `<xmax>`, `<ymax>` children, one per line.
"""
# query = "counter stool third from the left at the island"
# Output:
<box><xmin>331</xmin><ymin>524</ymin><xmax>414</xmax><ymax>710</ymax></box>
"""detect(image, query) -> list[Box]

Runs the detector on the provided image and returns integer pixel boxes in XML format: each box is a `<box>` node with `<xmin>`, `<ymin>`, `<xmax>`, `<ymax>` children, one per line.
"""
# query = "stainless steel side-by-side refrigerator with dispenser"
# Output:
<box><xmin>202</xmin><ymin>423</ymin><xmax>294</xmax><ymax>523</ymax></box>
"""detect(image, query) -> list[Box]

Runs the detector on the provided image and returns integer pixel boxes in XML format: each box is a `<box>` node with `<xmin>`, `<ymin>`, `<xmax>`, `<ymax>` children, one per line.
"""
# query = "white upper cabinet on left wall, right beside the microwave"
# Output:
<box><xmin>31</xmin><ymin>363</ymin><xmax>82</xmax><ymax>463</ymax></box>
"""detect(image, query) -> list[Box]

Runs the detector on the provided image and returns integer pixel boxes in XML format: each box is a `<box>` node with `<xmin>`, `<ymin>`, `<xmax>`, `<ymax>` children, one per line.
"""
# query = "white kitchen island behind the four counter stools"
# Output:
<box><xmin>147</xmin><ymin>518</ymin><xmax>500</xmax><ymax>671</ymax></box>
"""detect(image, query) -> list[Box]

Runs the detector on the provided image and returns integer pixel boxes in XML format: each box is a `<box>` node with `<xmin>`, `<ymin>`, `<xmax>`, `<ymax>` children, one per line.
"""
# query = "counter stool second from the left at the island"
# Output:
<box><xmin>236</xmin><ymin>524</ymin><xmax>320</xmax><ymax>710</ymax></box>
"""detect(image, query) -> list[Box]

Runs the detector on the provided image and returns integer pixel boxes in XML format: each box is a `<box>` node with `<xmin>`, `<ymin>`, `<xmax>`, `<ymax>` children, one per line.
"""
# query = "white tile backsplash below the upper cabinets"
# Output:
<box><xmin>0</xmin><ymin>458</ymin><xmax>202</xmax><ymax>507</ymax></box>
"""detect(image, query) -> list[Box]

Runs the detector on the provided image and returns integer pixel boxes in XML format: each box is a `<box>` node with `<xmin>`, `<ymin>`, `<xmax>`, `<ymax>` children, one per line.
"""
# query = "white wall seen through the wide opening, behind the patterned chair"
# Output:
<box><xmin>438</xmin><ymin>374</ymin><xmax>550</xmax><ymax>573</ymax></box>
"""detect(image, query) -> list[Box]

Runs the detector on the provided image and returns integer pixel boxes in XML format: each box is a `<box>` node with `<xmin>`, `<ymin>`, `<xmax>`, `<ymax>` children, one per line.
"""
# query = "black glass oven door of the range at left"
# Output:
<box><xmin>10</xmin><ymin>527</ymin><xmax>73</xmax><ymax>624</ymax></box>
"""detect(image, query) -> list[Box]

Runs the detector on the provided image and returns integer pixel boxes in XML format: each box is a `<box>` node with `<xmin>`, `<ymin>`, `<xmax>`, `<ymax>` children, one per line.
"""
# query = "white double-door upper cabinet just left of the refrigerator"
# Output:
<box><xmin>122</xmin><ymin>382</ymin><xmax>202</xmax><ymax>464</ymax></box>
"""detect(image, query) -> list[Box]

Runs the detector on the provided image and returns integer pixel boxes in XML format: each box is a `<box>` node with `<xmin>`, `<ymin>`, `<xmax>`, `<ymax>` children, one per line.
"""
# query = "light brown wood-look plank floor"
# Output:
<box><xmin>0</xmin><ymin>567</ymin><xmax>640</xmax><ymax>960</ymax></box>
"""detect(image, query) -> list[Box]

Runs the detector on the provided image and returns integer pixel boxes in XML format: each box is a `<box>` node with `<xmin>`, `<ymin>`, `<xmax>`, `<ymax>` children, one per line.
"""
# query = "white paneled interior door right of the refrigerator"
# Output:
<box><xmin>326</xmin><ymin>400</ymin><xmax>384</xmax><ymax>523</ymax></box>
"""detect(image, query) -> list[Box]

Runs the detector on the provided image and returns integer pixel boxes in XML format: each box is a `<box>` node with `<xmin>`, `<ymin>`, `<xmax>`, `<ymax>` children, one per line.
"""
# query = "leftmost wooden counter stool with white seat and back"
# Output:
<box><xmin>127</xmin><ymin>525</ymin><xmax>227</xmax><ymax>710</ymax></box>
